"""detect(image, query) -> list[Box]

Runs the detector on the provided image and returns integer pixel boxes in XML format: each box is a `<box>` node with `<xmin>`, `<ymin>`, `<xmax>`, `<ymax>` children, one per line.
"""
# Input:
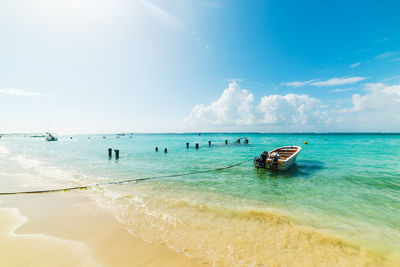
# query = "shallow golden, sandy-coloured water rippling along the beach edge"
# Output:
<box><xmin>89</xmin><ymin>185</ymin><xmax>398</xmax><ymax>266</ymax></box>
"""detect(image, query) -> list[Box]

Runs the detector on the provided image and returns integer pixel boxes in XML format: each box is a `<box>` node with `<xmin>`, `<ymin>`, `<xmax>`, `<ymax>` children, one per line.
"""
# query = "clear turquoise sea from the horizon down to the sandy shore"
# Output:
<box><xmin>0</xmin><ymin>133</ymin><xmax>400</xmax><ymax>265</ymax></box>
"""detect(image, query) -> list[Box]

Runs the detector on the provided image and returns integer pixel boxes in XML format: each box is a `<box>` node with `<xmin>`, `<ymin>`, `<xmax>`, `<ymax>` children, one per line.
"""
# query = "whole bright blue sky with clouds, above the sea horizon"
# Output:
<box><xmin>0</xmin><ymin>0</ymin><xmax>400</xmax><ymax>133</ymax></box>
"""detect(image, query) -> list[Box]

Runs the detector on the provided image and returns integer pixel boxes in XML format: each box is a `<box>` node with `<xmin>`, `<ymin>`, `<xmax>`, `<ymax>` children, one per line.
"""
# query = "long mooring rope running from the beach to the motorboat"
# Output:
<box><xmin>0</xmin><ymin>160</ymin><xmax>249</xmax><ymax>196</ymax></box>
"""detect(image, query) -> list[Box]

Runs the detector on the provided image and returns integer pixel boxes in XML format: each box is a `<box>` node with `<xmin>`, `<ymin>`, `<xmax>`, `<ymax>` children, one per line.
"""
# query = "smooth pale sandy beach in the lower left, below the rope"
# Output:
<box><xmin>0</xmin><ymin>191</ymin><xmax>207</xmax><ymax>266</ymax></box>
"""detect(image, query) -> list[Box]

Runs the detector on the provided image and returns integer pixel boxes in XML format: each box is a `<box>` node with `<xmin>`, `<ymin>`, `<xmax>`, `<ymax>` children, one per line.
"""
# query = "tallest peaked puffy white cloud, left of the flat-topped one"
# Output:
<box><xmin>186</xmin><ymin>81</ymin><xmax>254</xmax><ymax>125</ymax></box>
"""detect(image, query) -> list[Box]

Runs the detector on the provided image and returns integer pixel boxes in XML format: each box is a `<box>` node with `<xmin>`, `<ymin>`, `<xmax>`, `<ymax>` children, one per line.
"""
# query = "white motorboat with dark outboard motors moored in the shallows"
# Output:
<box><xmin>254</xmin><ymin>146</ymin><xmax>301</xmax><ymax>171</ymax></box>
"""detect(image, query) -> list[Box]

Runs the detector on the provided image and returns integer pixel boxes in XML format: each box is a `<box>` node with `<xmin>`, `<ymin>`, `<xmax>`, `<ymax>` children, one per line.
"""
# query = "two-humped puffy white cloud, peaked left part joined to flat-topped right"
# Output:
<box><xmin>186</xmin><ymin>81</ymin><xmax>326</xmax><ymax>129</ymax></box>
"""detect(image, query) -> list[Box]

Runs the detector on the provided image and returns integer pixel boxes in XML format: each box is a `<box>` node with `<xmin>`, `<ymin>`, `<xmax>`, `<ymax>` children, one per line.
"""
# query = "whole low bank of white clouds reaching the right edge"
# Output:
<box><xmin>186</xmin><ymin>81</ymin><xmax>400</xmax><ymax>132</ymax></box>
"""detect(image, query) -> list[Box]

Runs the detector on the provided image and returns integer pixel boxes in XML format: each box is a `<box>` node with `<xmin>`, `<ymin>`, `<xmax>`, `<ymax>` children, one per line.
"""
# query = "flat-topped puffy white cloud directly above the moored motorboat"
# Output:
<box><xmin>257</xmin><ymin>94</ymin><xmax>326</xmax><ymax>125</ymax></box>
